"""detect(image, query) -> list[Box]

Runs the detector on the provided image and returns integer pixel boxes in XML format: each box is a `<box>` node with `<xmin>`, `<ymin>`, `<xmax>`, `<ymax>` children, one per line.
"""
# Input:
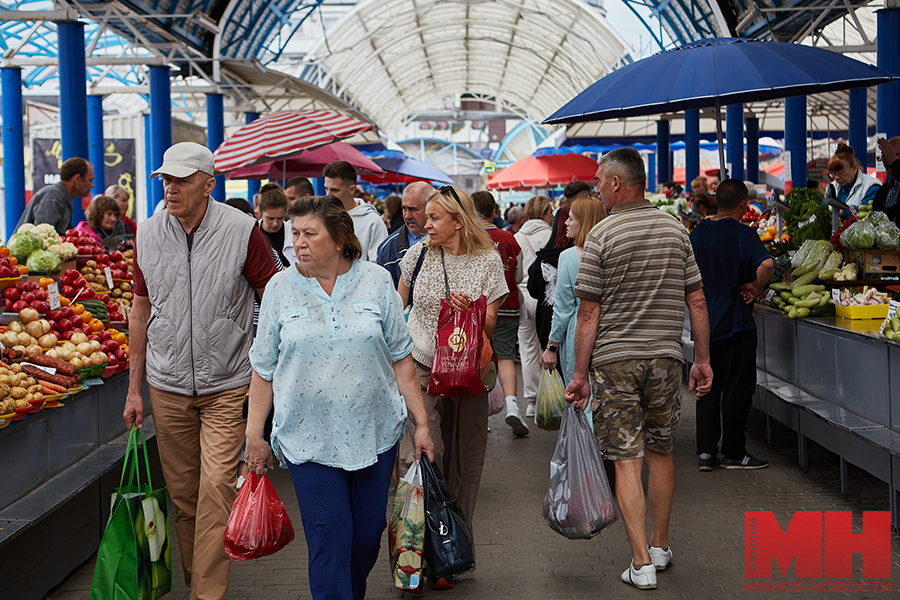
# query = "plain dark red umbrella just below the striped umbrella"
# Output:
<box><xmin>224</xmin><ymin>142</ymin><xmax>384</xmax><ymax>181</ymax></box>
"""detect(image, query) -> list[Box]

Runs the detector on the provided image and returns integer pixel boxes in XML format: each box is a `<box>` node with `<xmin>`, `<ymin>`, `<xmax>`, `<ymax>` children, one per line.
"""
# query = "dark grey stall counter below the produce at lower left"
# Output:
<box><xmin>0</xmin><ymin>370</ymin><xmax>162</xmax><ymax>600</ymax></box>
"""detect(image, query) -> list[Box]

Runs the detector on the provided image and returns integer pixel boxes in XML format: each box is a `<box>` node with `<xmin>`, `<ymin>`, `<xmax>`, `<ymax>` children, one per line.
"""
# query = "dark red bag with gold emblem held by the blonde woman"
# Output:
<box><xmin>428</xmin><ymin>296</ymin><xmax>487</xmax><ymax>398</ymax></box>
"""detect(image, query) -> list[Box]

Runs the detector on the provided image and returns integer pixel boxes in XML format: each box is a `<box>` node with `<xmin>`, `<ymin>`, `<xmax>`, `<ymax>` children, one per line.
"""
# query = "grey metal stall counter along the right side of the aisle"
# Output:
<box><xmin>754</xmin><ymin>305</ymin><xmax>900</xmax><ymax>529</ymax></box>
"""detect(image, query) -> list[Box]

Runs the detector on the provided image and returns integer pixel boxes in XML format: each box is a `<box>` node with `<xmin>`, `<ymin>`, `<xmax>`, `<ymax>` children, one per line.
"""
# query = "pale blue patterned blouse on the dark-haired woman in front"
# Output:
<box><xmin>250</xmin><ymin>260</ymin><xmax>413</xmax><ymax>471</ymax></box>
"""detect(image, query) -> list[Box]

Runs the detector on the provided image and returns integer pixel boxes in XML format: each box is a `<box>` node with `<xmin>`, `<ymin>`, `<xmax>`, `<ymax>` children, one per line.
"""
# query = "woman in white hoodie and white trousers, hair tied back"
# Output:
<box><xmin>516</xmin><ymin>196</ymin><xmax>553</xmax><ymax>417</ymax></box>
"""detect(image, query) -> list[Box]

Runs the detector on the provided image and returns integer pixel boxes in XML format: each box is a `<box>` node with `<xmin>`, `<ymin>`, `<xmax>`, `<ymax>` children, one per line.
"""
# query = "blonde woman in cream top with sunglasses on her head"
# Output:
<box><xmin>398</xmin><ymin>186</ymin><xmax>509</xmax><ymax>589</ymax></box>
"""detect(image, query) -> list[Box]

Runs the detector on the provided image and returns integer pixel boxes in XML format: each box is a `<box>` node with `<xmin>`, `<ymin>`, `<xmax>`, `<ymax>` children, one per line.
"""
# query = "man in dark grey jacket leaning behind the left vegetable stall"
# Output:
<box><xmin>16</xmin><ymin>157</ymin><xmax>94</xmax><ymax>235</ymax></box>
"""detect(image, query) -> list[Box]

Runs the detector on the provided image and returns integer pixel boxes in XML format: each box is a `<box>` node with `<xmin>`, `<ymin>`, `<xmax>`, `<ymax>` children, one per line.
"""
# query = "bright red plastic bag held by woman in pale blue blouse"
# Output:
<box><xmin>224</xmin><ymin>471</ymin><xmax>294</xmax><ymax>560</ymax></box>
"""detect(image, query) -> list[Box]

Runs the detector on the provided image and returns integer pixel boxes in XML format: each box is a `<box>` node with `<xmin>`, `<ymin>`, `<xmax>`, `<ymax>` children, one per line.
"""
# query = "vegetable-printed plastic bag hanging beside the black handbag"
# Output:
<box><xmin>388</xmin><ymin>462</ymin><xmax>425</xmax><ymax>591</ymax></box>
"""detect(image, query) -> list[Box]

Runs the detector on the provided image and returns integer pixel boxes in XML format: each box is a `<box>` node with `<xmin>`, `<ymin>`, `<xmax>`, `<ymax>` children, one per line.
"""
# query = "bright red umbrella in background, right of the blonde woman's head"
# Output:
<box><xmin>485</xmin><ymin>154</ymin><xmax>597</xmax><ymax>190</ymax></box>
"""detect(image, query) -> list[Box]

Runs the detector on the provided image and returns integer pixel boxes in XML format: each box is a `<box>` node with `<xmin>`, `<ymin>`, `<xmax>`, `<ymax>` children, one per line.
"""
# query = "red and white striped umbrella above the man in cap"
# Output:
<box><xmin>214</xmin><ymin>110</ymin><xmax>372</xmax><ymax>173</ymax></box>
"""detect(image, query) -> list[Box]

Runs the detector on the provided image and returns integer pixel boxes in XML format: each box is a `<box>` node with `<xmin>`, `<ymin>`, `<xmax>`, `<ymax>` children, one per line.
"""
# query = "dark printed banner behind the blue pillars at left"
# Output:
<box><xmin>32</xmin><ymin>138</ymin><xmax>137</xmax><ymax>216</ymax></box>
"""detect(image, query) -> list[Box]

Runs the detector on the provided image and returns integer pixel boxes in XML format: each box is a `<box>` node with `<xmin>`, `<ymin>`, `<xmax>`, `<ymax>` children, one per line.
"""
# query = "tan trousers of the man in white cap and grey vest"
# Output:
<box><xmin>150</xmin><ymin>386</ymin><xmax>248</xmax><ymax>600</ymax></box>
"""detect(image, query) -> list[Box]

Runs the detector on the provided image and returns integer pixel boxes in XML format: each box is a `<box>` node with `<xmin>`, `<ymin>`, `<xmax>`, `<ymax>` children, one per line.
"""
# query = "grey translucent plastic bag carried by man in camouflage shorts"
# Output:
<box><xmin>543</xmin><ymin>404</ymin><xmax>619</xmax><ymax>540</ymax></box>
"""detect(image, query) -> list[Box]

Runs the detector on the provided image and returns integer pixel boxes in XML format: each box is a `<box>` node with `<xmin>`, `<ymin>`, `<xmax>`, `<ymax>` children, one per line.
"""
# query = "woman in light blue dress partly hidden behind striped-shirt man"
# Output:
<box><xmin>541</xmin><ymin>196</ymin><xmax>606</xmax><ymax>383</ymax></box>
